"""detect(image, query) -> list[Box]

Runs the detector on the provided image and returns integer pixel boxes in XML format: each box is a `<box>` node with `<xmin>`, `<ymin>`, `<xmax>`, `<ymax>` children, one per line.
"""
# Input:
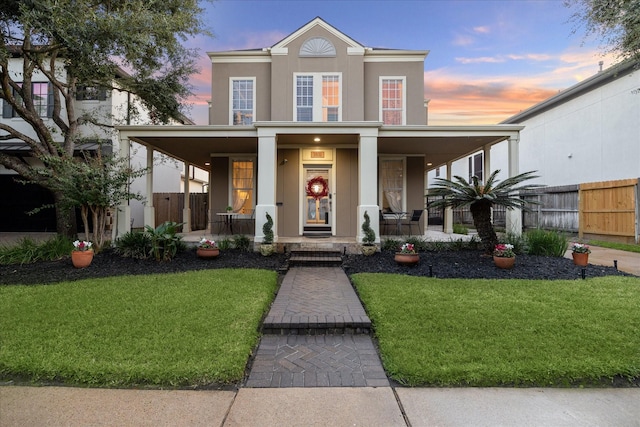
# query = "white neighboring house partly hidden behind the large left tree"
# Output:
<box><xmin>0</xmin><ymin>54</ymin><xmax>190</xmax><ymax>231</ymax></box>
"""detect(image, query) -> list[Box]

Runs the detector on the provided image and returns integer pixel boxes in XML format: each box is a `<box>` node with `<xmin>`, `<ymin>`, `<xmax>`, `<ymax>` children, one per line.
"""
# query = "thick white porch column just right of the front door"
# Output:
<box><xmin>356</xmin><ymin>129</ymin><xmax>380</xmax><ymax>243</ymax></box>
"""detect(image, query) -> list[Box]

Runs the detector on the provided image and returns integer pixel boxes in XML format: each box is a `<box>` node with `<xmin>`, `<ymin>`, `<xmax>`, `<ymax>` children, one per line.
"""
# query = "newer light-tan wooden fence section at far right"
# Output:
<box><xmin>578</xmin><ymin>178</ymin><xmax>640</xmax><ymax>243</ymax></box>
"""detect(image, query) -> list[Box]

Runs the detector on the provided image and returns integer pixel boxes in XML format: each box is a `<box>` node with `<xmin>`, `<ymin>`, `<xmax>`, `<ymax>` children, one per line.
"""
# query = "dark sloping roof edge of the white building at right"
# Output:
<box><xmin>500</xmin><ymin>60</ymin><xmax>638</xmax><ymax>124</ymax></box>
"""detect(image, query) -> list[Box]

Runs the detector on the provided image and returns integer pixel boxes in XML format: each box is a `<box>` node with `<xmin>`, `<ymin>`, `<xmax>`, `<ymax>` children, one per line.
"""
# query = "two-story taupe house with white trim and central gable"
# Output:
<box><xmin>119</xmin><ymin>18</ymin><xmax>522</xmax><ymax>247</ymax></box>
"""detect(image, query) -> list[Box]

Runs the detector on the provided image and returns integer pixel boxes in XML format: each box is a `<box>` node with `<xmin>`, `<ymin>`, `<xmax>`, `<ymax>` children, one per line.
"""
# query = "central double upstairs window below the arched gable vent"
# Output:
<box><xmin>294</xmin><ymin>73</ymin><xmax>342</xmax><ymax>122</ymax></box>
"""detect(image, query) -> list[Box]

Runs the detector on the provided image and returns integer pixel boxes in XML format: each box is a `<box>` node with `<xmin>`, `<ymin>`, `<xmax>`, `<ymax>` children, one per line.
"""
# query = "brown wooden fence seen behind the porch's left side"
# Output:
<box><xmin>153</xmin><ymin>193</ymin><xmax>209</xmax><ymax>230</ymax></box>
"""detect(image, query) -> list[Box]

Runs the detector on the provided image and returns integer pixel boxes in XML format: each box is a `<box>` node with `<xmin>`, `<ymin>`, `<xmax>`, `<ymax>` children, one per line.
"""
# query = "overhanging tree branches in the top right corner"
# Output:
<box><xmin>565</xmin><ymin>0</ymin><xmax>640</xmax><ymax>63</ymax></box>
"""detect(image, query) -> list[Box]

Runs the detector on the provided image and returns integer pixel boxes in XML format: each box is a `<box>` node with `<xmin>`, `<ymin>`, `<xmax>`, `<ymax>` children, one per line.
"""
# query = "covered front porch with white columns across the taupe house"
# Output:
<box><xmin>115</xmin><ymin>122</ymin><xmax>522</xmax><ymax>247</ymax></box>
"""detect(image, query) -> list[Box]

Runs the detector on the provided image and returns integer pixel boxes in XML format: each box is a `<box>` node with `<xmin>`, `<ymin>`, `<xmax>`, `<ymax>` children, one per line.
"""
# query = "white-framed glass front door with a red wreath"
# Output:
<box><xmin>303</xmin><ymin>166</ymin><xmax>333</xmax><ymax>235</ymax></box>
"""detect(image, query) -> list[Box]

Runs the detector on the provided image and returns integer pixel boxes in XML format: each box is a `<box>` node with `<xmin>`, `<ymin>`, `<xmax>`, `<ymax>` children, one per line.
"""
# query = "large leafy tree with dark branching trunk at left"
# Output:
<box><xmin>0</xmin><ymin>0</ymin><xmax>207</xmax><ymax>233</ymax></box>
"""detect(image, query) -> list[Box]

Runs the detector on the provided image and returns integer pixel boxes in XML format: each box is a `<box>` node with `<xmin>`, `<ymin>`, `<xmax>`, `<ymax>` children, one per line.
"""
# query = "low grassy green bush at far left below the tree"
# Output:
<box><xmin>0</xmin><ymin>234</ymin><xmax>73</xmax><ymax>265</ymax></box>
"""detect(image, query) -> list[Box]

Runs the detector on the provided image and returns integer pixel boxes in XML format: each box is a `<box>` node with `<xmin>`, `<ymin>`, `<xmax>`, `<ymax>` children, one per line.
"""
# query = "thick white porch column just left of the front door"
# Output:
<box><xmin>254</xmin><ymin>129</ymin><xmax>278</xmax><ymax>243</ymax></box>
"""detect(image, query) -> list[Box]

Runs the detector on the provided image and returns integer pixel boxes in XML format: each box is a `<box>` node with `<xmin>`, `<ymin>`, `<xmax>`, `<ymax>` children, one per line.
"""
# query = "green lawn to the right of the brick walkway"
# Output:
<box><xmin>353</xmin><ymin>273</ymin><xmax>640</xmax><ymax>386</ymax></box>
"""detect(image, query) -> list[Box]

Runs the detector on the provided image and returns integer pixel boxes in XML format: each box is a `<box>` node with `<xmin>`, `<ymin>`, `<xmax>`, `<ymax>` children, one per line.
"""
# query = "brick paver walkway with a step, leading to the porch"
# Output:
<box><xmin>245</xmin><ymin>267</ymin><xmax>389</xmax><ymax>387</ymax></box>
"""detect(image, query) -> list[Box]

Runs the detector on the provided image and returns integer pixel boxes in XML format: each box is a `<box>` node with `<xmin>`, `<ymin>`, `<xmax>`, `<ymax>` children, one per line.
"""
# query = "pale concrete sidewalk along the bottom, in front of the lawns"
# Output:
<box><xmin>0</xmin><ymin>386</ymin><xmax>640</xmax><ymax>427</ymax></box>
